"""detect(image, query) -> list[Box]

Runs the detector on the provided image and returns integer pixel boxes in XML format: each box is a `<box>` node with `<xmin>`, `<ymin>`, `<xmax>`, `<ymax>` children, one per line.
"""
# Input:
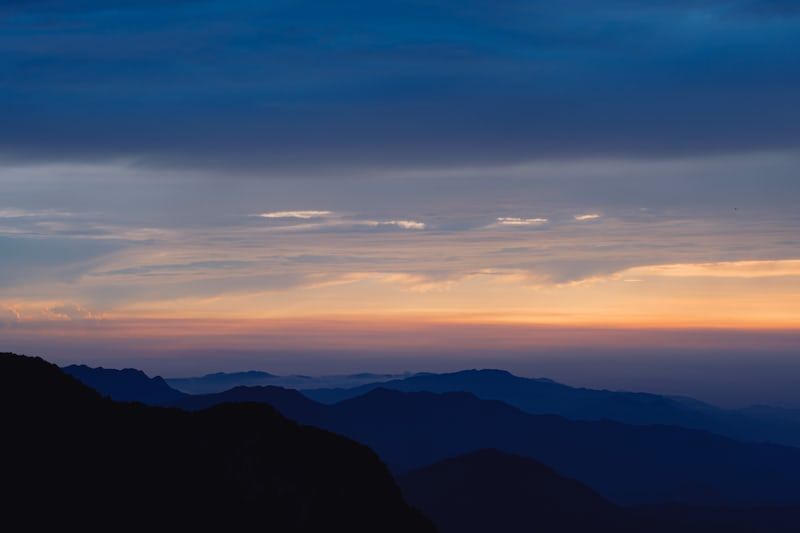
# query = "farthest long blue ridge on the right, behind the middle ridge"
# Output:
<box><xmin>303</xmin><ymin>370</ymin><xmax>800</xmax><ymax>446</ymax></box>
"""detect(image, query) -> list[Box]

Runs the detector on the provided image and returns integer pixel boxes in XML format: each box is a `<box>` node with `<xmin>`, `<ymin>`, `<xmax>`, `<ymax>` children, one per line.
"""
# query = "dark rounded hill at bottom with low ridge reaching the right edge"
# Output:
<box><xmin>398</xmin><ymin>450</ymin><xmax>800</xmax><ymax>533</ymax></box>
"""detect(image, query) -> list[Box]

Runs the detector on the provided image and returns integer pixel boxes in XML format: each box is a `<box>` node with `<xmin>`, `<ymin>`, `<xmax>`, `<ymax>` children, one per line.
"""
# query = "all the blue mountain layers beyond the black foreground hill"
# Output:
<box><xmin>53</xmin><ymin>360</ymin><xmax>800</xmax><ymax>533</ymax></box>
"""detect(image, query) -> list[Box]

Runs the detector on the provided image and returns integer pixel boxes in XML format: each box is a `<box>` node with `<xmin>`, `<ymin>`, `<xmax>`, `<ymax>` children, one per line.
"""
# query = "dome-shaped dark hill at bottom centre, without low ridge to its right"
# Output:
<box><xmin>398</xmin><ymin>450</ymin><xmax>640</xmax><ymax>533</ymax></box>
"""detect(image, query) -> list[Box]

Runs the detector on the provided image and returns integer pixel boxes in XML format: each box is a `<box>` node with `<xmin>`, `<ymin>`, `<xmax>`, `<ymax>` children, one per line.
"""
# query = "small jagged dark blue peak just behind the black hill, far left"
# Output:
<box><xmin>61</xmin><ymin>365</ymin><xmax>185</xmax><ymax>405</ymax></box>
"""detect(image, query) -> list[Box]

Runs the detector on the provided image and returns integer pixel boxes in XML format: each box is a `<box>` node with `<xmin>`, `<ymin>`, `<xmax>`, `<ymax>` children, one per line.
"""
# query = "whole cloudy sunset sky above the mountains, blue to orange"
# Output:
<box><xmin>0</xmin><ymin>0</ymin><xmax>800</xmax><ymax>407</ymax></box>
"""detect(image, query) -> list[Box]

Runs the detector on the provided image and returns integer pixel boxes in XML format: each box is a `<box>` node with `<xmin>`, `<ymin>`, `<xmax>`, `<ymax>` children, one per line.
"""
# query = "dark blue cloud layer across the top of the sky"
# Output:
<box><xmin>0</xmin><ymin>0</ymin><xmax>800</xmax><ymax>174</ymax></box>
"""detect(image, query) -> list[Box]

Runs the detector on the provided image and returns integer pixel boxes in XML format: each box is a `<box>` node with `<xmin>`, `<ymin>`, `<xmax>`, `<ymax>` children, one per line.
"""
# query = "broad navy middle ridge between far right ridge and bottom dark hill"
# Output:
<box><xmin>172</xmin><ymin>387</ymin><xmax>800</xmax><ymax>505</ymax></box>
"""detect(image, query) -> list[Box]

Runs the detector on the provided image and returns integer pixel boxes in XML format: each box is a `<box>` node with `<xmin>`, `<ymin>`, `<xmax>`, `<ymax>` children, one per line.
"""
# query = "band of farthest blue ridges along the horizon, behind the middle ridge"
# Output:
<box><xmin>72</xmin><ymin>365</ymin><xmax>800</xmax><ymax>446</ymax></box>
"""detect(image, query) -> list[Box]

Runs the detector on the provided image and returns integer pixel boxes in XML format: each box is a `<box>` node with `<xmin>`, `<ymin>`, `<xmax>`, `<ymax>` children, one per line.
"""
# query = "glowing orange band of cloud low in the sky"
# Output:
<box><xmin>6</xmin><ymin>260</ymin><xmax>800</xmax><ymax>330</ymax></box>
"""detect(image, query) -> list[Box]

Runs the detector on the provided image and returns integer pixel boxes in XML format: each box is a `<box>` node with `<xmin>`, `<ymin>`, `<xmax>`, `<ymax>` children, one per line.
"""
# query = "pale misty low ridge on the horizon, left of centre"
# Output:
<box><xmin>167</xmin><ymin>370</ymin><xmax>402</xmax><ymax>394</ymax></box>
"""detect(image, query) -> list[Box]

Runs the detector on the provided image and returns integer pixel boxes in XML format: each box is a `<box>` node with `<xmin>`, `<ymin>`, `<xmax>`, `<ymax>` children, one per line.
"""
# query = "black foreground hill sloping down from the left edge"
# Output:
<box><xmin>0</xmin><ymin>354</ymin><xmax>433</xmax><ymax>532</ymax></box>
